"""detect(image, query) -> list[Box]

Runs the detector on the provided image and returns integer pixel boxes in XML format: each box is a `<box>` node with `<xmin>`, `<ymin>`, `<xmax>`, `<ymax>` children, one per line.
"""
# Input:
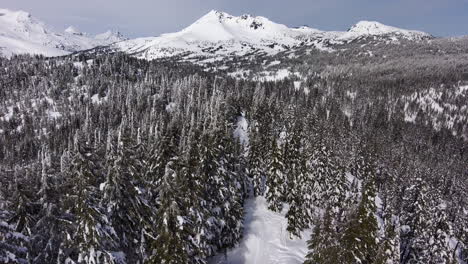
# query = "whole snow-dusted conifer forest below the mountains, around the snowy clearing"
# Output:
<box><xmin>0</xmin><ymin>53</ymin><xmax>468</xmax><ymax>264</ymax></box>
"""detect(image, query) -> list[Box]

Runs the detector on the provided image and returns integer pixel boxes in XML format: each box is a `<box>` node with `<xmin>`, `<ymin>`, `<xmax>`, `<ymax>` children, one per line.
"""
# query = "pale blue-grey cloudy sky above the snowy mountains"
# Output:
<box><xmin>0</xmin><ymin>0</ymin><xmax>468</xmax><ymax>37</ymax></box>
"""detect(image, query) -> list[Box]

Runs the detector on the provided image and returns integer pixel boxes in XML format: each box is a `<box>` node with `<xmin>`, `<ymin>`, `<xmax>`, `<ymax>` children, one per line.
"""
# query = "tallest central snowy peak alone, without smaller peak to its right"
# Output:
<box><xmin>110</xmin><ymin>11</ymin><xmax>308</xmax><ymax>59</ymax></box>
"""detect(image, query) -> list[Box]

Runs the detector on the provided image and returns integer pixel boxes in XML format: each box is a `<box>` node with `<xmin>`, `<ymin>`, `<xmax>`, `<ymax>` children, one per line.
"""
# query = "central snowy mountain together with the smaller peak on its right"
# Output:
<box><xmin>111</xmin><ymin>10</ymin><xmax>430</xmax><ymax>60</ymax></box>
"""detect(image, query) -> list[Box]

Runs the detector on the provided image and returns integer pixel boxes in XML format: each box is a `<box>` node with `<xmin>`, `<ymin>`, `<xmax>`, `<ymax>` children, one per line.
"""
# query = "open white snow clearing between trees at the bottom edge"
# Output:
<box><xmin>209</xmin><ymin>197</ymin><xmax>311</xmax><ymax>264</ymax></box>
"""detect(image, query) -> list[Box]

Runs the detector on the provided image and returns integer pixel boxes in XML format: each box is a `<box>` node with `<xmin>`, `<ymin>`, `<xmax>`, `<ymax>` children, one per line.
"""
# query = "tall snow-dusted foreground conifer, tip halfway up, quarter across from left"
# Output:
<box><xmin>100</xmin><ymin>128</ymin><xmax>152</xmax><ymax>259</ymax></box>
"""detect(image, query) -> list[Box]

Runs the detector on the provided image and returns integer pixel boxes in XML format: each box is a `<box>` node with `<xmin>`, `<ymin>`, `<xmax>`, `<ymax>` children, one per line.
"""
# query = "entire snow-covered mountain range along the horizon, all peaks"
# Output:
<box><xmin>0</xmin><ymin>9</ymin><xmax>433</xmax><ymax>60</ymax></box>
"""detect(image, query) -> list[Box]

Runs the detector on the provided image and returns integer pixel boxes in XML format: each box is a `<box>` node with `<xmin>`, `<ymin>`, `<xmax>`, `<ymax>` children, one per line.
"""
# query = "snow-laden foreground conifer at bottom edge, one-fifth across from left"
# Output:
<box><xmin>62</xmin><ymin>138</ymin><xmax>118</xmax><ymax>264</ymax></box>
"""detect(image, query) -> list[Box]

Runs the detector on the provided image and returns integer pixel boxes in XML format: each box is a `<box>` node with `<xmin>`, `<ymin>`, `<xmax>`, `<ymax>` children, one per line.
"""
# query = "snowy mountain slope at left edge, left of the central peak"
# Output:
<box><xmin>0</xmin><ymin>9</ymin><xmax>124</xmax><ymax>56</ymax></box>
